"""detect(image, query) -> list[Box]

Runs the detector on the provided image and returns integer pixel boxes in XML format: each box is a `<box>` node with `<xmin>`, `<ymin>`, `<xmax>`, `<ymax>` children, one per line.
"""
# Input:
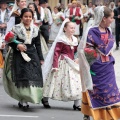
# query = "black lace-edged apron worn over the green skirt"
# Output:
<box><xmin>11</xmin><ymin>45</ymin><xmax>43</xmax><ymax>87</ymax></box>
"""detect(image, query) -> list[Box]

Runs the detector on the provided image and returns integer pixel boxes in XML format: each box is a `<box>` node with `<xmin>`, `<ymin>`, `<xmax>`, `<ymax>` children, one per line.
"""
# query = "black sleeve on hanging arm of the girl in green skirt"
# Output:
<box><xmin>35</xmin><ymin>32</ymin><xmax>44</xmax><ymax>60</ymax></box>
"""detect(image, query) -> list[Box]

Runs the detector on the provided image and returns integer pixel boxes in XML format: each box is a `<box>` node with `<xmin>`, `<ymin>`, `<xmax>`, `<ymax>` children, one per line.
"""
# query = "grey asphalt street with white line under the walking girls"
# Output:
<box><xmin>0</xmin><ymin>45</ymin><xmax>120</xmax><ymax>120</ymax></box>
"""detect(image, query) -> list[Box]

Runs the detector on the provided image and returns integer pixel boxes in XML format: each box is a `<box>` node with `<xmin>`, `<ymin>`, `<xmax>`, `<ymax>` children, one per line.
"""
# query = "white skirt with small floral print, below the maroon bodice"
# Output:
<box><xmin>43</xmin><ymin>59</ymin><xmax>81</xmax><ymax>101</ymax></box>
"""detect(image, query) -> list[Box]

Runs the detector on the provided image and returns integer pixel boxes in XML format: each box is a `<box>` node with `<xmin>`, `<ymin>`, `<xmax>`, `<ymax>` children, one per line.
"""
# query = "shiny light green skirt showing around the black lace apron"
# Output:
<box><xmin>3</xmin><ymin>49</ymin><xmax>42</xmax><ymax>104</ymax></box>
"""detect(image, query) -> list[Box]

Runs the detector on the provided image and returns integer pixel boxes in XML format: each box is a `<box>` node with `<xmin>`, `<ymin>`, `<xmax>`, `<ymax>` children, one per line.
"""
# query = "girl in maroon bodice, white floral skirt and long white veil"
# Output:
<box><xmin>42</xmin><ymin>19</ymin><xmax>81</xmax><ymax>110</ymax></box>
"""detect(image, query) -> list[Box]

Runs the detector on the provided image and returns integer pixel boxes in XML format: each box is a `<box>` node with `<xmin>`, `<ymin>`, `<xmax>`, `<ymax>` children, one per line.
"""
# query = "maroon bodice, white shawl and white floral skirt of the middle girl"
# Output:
<box><xmin>43</xmin><ymin>35</ymin><xmax>81</xmax><ymax>101</ymax></box>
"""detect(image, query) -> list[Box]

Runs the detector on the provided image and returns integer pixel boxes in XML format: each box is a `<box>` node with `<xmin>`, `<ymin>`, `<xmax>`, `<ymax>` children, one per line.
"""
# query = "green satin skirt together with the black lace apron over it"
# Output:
<box><xmin>3</xmin><ymin>48</ymin><xmax>43</xmax><ymax>103</ymax></box>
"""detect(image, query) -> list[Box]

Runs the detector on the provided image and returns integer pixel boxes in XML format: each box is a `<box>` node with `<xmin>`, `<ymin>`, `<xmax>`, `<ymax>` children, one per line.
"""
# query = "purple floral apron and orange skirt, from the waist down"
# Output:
<box><xmin>82</xmin><ymin>56</ymin><xmax>120</xmax><ymax>120</ymax></box>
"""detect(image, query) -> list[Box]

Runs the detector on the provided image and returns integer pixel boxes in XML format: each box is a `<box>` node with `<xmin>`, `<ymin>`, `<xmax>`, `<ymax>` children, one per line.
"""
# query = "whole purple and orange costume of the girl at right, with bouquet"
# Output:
<box><xmin>82</xmin><ymin>27</ymin><xmax>120</xmax><ymax>120</ymax></box>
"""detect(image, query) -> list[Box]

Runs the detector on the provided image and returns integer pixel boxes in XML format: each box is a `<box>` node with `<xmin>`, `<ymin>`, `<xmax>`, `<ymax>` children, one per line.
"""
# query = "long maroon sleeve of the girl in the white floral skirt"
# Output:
<box><xmin>53</xmin><ymin>42</ymin><xmax>63</xmax><ymax>68</ymax></box>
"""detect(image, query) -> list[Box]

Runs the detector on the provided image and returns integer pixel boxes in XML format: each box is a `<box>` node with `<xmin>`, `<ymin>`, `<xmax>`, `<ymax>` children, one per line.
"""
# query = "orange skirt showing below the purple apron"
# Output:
<box><xmin>81</xmin><ymin>92</ymin><xmax>120</xmax><ymax>120</ymax></box>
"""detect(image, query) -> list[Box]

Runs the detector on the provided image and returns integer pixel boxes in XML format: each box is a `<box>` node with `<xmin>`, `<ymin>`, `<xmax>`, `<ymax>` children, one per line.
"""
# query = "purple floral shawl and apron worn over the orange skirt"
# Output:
<box><xmin>87</xmin><ymin>27</ymin><xmax>120</xmax><ymax>108</ymax></box>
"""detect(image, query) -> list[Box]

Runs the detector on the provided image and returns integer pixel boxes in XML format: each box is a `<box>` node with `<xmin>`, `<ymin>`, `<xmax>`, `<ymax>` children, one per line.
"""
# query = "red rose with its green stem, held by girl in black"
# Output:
<box><xmin>5</xmin><ymin>31</ymin><xmax>21</xmax><ymax>44</ymax></box>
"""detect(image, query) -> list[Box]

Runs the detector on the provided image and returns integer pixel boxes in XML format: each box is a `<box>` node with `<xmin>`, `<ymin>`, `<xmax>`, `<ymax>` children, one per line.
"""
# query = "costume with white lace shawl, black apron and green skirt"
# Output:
<box><xmin>3</xmin><ymin>23</ymin><xmax>43</xmax><ymax>103</ymax></box>
